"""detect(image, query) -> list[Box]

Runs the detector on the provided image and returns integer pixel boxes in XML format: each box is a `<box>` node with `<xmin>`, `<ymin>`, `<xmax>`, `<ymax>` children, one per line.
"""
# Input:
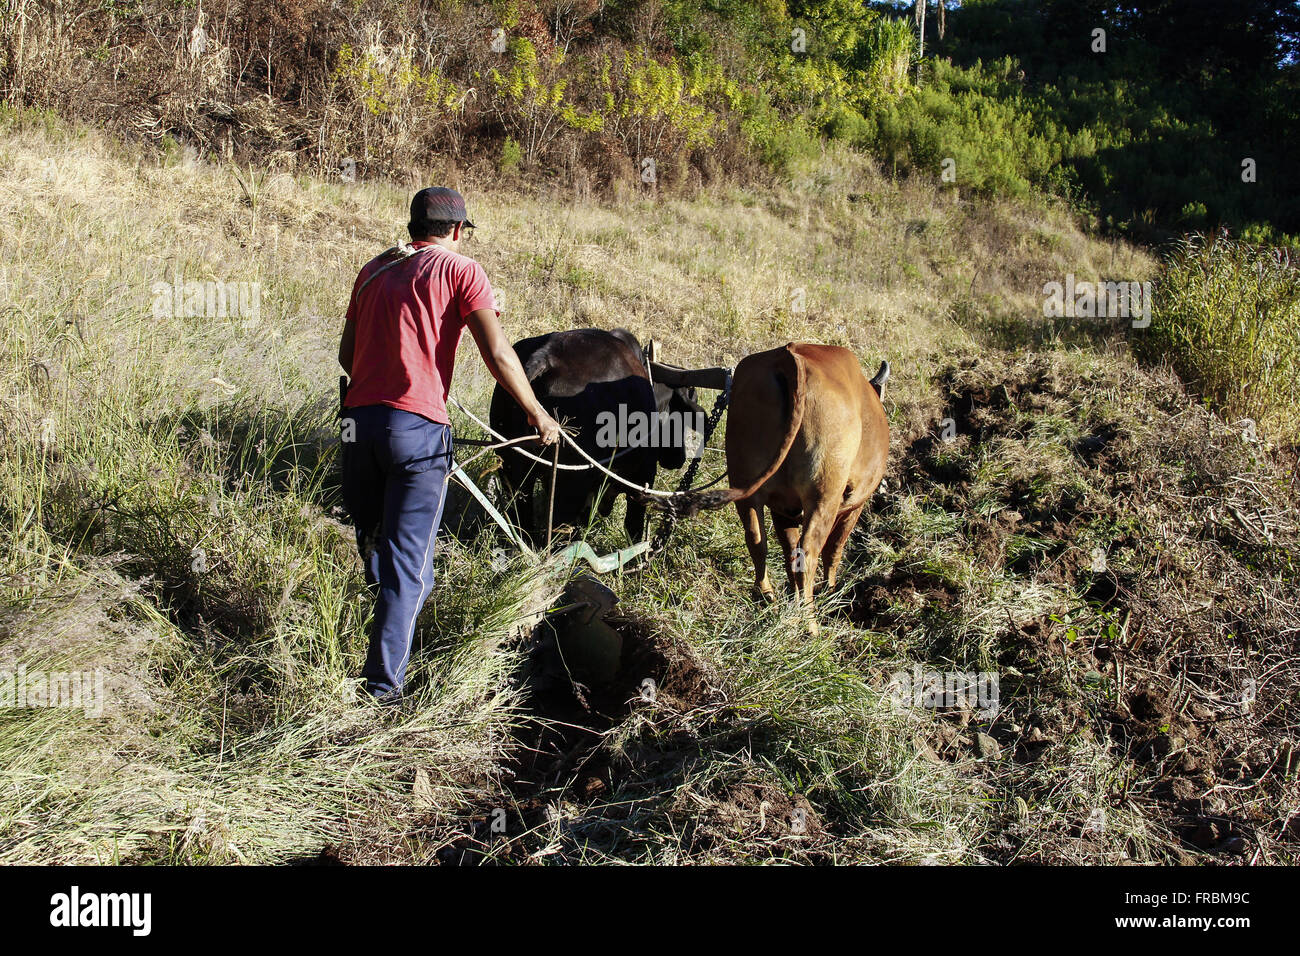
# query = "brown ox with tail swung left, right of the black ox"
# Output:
<box><xmin>677</xmin><ymin>342</ymin><xmax>889</xmax><ymax>627</ymax></box>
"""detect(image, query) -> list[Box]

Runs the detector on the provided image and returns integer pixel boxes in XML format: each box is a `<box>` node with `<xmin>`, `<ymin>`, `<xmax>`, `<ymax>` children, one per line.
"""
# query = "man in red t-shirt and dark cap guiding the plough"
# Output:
<box><xmin>338</xmin><ymin>189</ymin><xmax>560</xmax><ymax>702</ymax></box>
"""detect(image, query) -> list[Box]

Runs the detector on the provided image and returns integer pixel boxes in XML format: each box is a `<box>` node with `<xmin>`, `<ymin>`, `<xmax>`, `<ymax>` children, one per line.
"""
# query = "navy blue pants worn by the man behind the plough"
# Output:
<box><xmin>341</xmin><ymin>405</ymin><xmax>451</xmax><ymax>698</ymax></box>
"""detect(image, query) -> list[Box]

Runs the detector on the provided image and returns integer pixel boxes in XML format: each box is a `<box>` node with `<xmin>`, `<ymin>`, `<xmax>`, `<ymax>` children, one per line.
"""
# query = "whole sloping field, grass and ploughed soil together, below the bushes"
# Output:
<box><xmin>0</xmin><ymin>117</ymin><xmax>1300</xmax><ymax>862</ymax></box>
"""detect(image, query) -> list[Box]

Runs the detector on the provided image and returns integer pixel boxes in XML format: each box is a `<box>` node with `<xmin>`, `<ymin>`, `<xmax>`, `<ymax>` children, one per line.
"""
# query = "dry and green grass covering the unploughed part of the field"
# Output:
<box><xmin>10</xmin><ymin>111</ymin><xmax>1268</xmax><ymax>862</ymax></box>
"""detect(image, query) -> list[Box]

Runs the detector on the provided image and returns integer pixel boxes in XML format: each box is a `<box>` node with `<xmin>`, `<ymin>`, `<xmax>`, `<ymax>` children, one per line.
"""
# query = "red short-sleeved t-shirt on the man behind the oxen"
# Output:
<box><xmin>345</xmin><ymin>242</ymin><xmax>497</xmax><ymax>424</ymax></box>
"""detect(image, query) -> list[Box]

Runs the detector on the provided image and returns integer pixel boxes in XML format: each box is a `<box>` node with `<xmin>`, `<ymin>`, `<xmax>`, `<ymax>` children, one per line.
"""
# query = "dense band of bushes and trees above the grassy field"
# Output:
<box><xmin>0</xmin><ymin>0</ymin><xmax>1300</xmax><ymax>236</ymax></box>
